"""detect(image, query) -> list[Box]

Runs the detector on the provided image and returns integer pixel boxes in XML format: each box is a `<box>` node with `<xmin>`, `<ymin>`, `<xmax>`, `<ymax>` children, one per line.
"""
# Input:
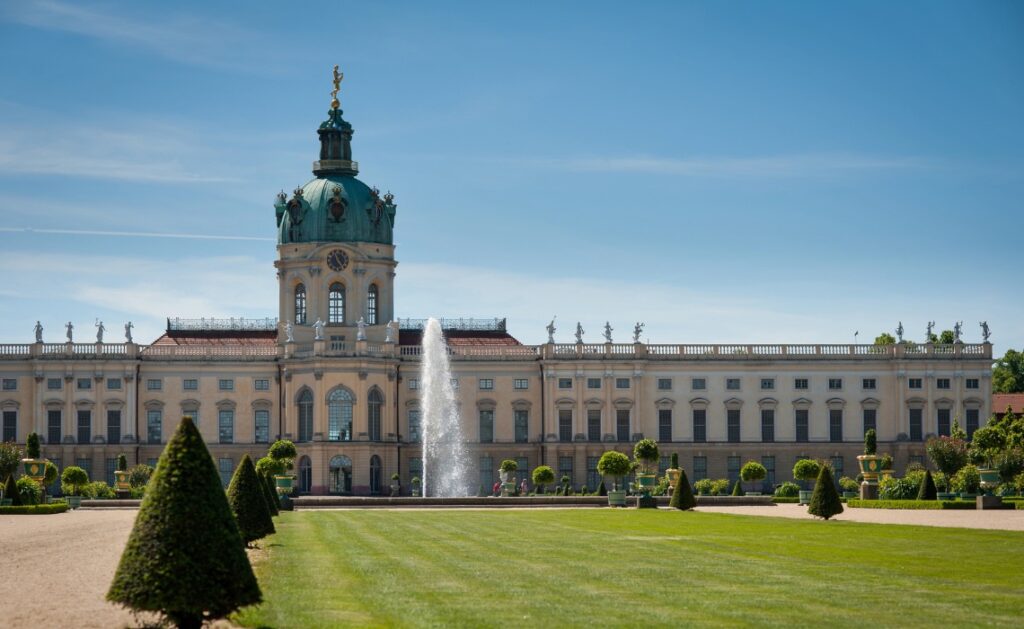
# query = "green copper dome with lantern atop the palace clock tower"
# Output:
<box><xmin>274</xmin><ymin>107</ymin><xmax>396</xmax><ymax>245</ymax></box>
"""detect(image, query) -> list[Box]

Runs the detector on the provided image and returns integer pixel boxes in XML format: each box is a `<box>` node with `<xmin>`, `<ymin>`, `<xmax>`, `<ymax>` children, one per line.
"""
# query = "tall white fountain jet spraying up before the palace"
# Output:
<box><xmin>420</xmin><ymin>319</ymin><xmax>473</xmax><ymax>498</ymax></box>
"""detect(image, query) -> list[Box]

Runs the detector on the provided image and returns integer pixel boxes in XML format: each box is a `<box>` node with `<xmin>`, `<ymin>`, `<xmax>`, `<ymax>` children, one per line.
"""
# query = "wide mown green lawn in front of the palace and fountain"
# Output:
<box><xmin>236</xmin><ymin>509</ymin><xmax>1024</xmax><ymax>628</ymax></box>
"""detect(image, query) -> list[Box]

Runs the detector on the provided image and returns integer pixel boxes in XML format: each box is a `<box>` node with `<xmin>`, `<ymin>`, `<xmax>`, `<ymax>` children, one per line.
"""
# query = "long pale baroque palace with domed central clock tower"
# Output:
<box><xmin>0</xmin><ymin>78</ymin><xmax>992</xmax><ymax>495</ymax></box>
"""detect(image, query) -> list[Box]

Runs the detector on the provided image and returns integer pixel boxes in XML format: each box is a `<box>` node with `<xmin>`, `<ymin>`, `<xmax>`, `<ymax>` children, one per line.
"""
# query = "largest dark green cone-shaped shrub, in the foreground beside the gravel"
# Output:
<box><xmin>106</xmin><ymin>417</ymin><xmax>261</xmax><ymax>628</ymax></box>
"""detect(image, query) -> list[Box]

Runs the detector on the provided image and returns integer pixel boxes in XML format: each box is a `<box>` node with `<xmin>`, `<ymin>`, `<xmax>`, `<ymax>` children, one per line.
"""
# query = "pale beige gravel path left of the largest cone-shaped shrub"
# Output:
<box><xmin>0</xmin><ymin>509</ymin><xmax>151</xmax><ymax>628</ymax></box>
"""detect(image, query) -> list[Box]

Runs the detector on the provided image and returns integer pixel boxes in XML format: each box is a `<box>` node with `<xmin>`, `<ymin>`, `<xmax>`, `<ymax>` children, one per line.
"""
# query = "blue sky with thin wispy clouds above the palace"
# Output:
<box><xmin>0</xmin><ymin>1</ymin><xmax>1024</xmax><ymax>353</ymax></box>
